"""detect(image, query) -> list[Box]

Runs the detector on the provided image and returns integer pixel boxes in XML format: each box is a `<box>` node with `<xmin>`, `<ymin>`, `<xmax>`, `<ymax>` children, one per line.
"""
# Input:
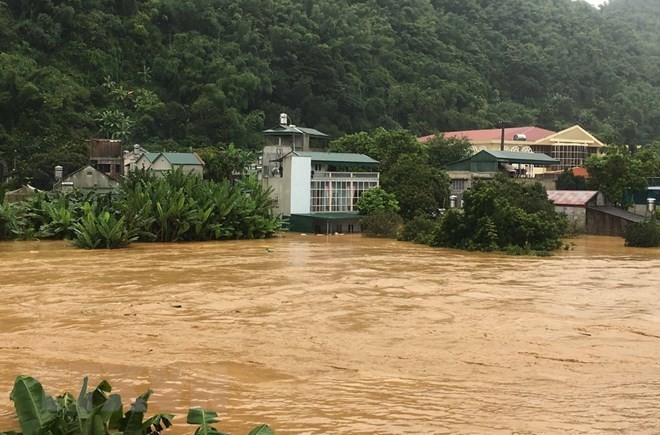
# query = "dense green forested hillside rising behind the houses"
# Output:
<box><xmin>0</xmin><ymin>0</ymin><xmax>660</xmax><ymax>187</ymax></box>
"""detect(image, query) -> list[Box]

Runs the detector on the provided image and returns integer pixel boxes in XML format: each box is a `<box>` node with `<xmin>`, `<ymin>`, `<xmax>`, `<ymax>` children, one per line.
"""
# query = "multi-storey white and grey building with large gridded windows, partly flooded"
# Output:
<box><xmin>260</xmin><ymin>114</ymin><xmax>380</xmax><ymax>234</ymax></box>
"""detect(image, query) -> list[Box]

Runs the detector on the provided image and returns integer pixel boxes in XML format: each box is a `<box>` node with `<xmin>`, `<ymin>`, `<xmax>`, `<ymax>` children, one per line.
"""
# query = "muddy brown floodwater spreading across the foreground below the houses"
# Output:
<box><xmin>0</xmin><ymin>234</ymin><xmax>660</xmax><ymax>434</ymax></box>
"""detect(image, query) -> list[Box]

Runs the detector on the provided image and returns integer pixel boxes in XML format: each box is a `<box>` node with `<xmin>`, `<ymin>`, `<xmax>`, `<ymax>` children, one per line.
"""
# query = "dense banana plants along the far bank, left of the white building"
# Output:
<box><xmin>0</xmin><ymin>171</ymin><xmax>281</xmax><ymax>249</ymax></box>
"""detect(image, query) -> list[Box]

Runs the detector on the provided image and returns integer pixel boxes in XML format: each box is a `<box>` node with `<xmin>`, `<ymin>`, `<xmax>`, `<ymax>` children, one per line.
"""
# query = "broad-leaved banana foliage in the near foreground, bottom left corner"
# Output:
<box><xmin>0</xmin><ymin>376</ymin><xmax>273</xmax><ymax>435</ymax></box>
